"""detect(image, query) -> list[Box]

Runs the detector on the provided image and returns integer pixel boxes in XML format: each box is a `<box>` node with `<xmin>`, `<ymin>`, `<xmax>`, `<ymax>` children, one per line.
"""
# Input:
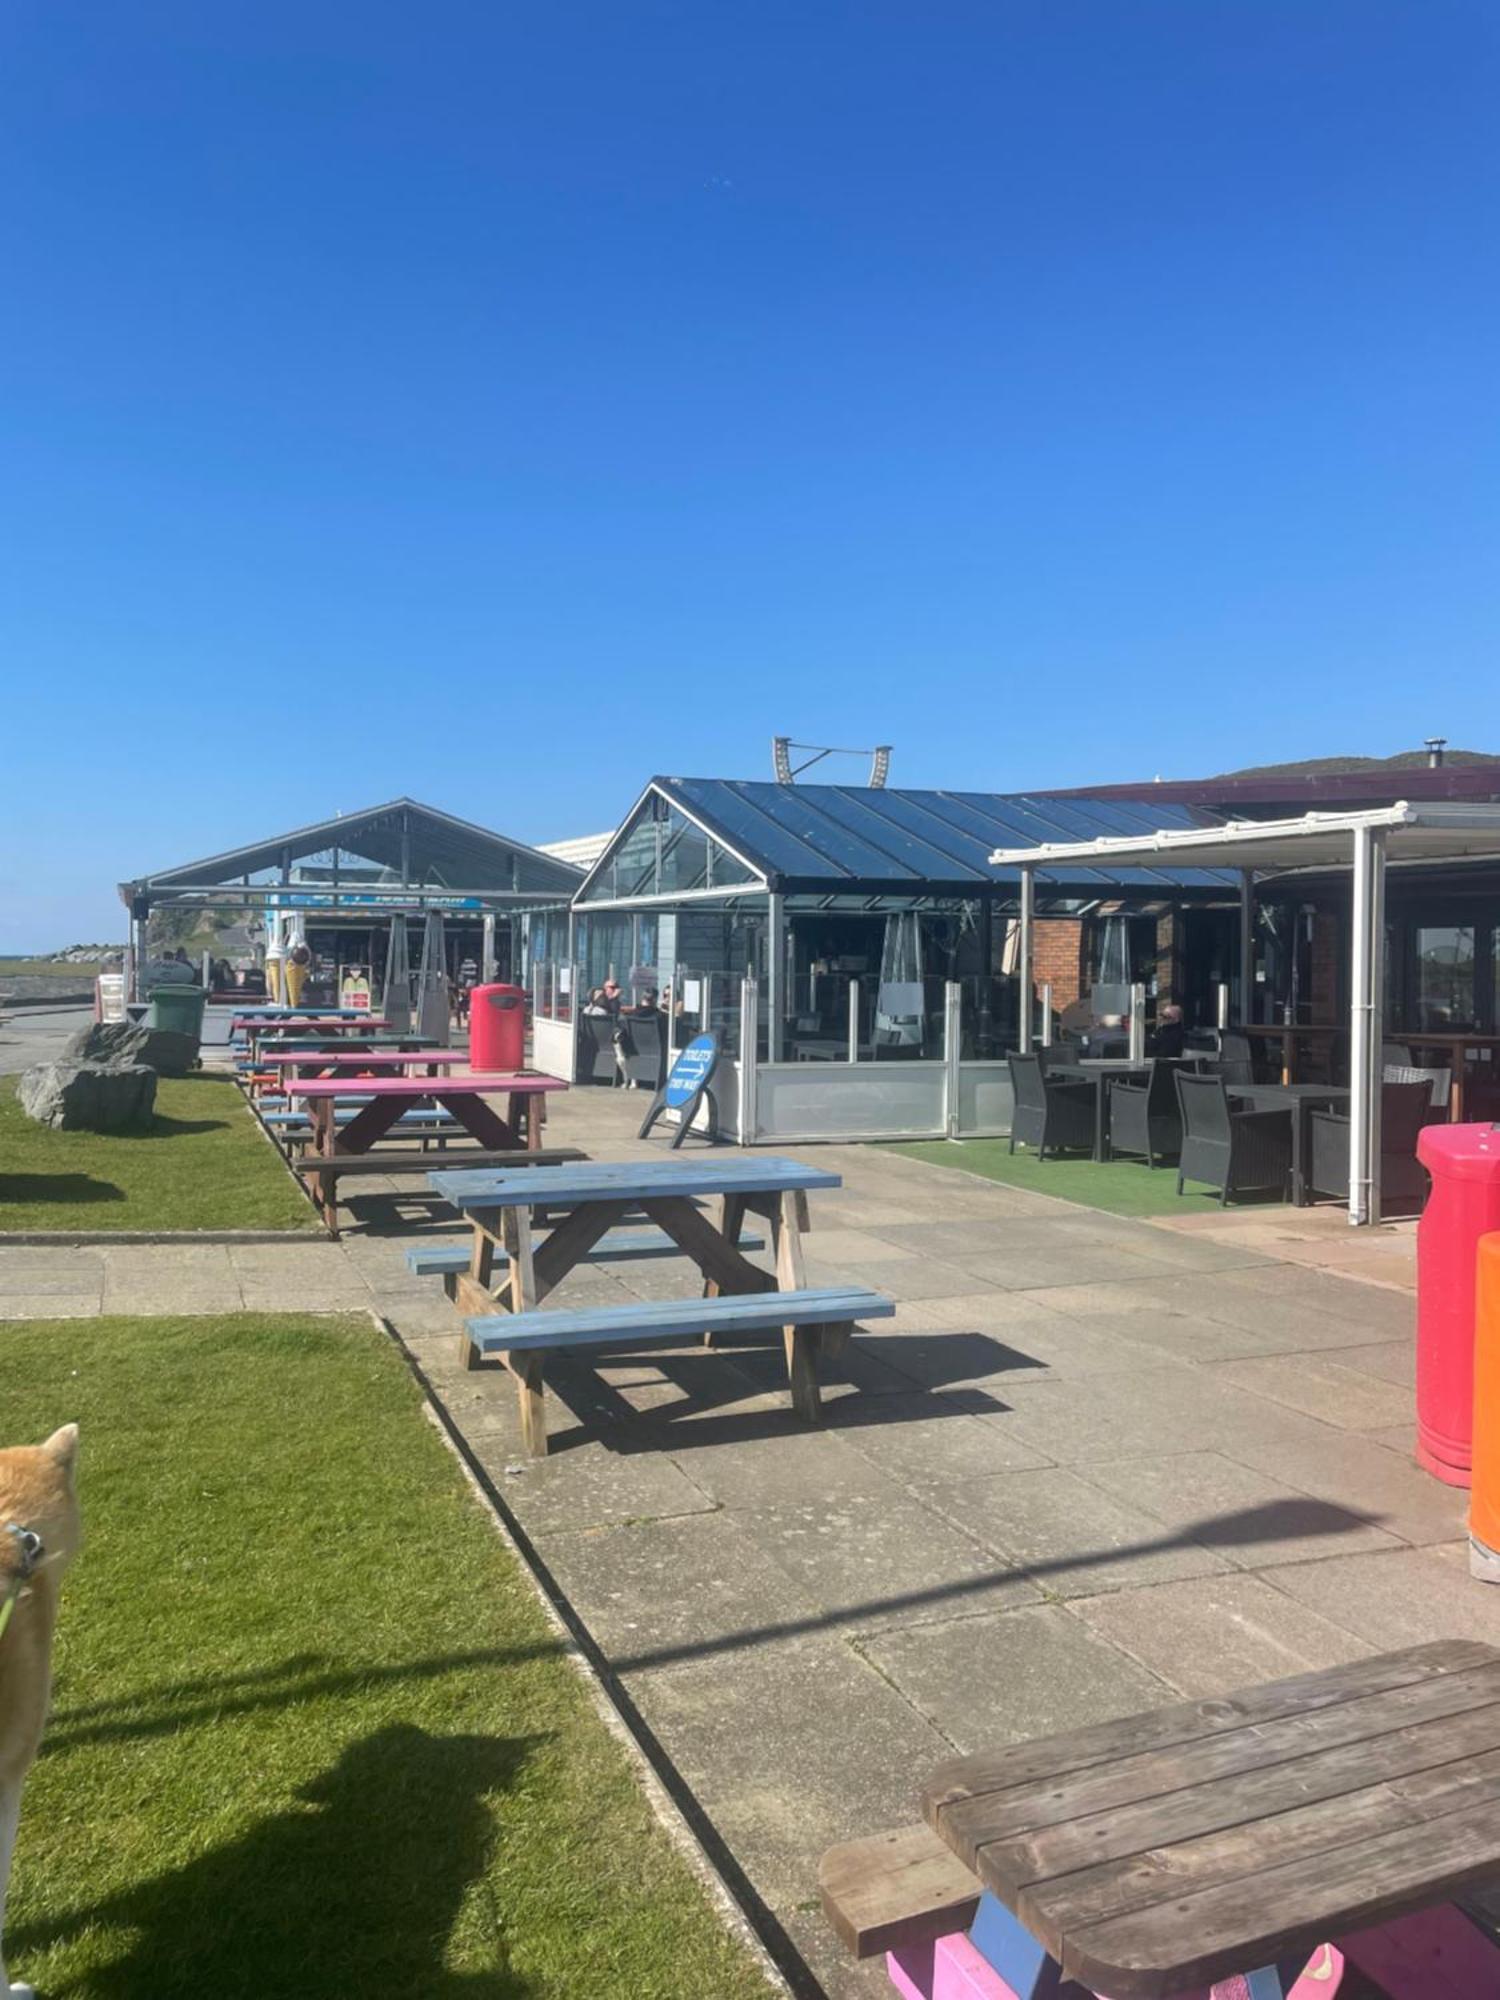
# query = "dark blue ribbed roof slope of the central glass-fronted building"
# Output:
<box><xmin>652</xmin><ymin>778</ymin><xmax>1236</xmax><ymax>894</ymax></box>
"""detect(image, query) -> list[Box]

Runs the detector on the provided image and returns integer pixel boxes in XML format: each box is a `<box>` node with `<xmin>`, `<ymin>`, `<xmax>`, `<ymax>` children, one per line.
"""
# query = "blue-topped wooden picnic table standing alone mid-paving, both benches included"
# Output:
<box><xmin>418</xmin><ymin>1156</ymin><xmax>894</xmax><ymax>1458</ymax></box>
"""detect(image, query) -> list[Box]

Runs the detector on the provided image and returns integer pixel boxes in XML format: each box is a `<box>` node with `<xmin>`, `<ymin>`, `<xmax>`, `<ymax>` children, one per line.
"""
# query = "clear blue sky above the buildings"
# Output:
<box><xmin>0</xmin><ymin>0</ymin><xmax>1500</xmax><ymax>948</ymax></box>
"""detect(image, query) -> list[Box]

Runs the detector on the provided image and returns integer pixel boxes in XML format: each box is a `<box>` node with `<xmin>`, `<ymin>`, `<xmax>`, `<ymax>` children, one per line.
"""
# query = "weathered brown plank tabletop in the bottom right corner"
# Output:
<box><xmin>922</xmin><ymin>1640</ymin><xmax>1500</xmax><ymax>2000</ymax></box>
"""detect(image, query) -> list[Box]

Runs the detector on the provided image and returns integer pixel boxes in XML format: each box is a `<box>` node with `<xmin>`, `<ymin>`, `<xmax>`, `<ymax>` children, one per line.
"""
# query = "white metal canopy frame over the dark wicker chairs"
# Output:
<box><xmin>990</xmin><ymin>800</ymin><xmax>1500</xmax><ymax>1226</ymax></box>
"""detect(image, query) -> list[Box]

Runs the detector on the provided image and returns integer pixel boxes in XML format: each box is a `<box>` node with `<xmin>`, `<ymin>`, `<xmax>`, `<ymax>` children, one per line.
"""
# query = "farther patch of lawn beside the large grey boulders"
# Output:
<box><xmin>0</xmin><ymin>1076</ymin><xmax>318</xmax><ymax>1234</ymax></box>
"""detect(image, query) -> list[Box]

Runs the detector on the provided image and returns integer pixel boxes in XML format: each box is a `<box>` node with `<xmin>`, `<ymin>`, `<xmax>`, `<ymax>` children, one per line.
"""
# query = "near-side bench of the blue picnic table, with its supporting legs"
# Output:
<box><xmin>462</xmin><ymin>1286</ymin><xmax>896</xmax><ymax>1458</ymax></box>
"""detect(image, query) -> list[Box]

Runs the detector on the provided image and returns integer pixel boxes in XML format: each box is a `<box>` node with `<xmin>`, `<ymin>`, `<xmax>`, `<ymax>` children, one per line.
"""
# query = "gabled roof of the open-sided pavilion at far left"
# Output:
<box><xmin>120</xmin><ymin>798</ymin><xmax>582</xmax><ymax>898</ymax></box>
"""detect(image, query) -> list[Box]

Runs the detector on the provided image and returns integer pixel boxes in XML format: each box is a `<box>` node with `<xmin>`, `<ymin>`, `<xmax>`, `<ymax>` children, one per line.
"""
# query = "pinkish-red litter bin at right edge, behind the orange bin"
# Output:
<box><xmin>1416</xmin><ymin>1124</ymin><xmax>1500</xmax><ymax>1486</ymax></box>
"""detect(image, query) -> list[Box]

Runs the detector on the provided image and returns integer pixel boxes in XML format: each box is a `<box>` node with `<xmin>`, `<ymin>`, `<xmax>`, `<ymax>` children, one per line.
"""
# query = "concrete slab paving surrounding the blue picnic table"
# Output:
<box><xmin>0</xmin><ymin>1090</ymin><xmax>1500</xmax><ymax>1996</ymax></box>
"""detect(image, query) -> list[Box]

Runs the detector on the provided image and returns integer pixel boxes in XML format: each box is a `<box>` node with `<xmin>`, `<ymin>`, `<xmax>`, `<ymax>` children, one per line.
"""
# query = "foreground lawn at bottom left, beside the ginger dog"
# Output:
<box><xmin>4</xmin><ymin>1314</ymin><xmax>788</xmax><ymax>2000</ymax></box>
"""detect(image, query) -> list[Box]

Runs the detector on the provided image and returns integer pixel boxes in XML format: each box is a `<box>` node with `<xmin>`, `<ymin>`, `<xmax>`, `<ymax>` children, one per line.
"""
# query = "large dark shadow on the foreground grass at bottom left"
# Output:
<box><xmin>6</xmin><ymin>1722</ymin><xmax>542</xmax><ymax>2000</ymax></box>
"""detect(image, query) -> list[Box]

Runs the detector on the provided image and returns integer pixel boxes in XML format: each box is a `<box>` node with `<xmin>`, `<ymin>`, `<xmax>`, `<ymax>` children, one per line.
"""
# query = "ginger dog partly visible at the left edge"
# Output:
<box><xmin>0</xmin><ymin>1424</ymin><xmax>80</xmax><ymax>2000</ymax></box>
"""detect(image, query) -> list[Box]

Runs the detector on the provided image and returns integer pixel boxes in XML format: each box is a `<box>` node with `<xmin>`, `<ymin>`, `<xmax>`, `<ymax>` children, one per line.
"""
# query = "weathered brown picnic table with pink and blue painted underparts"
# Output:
<box><xmin>818</xmin><ymin>1640</ymin><xmax>1500</xmax><ymax>2000</ymax></box>
